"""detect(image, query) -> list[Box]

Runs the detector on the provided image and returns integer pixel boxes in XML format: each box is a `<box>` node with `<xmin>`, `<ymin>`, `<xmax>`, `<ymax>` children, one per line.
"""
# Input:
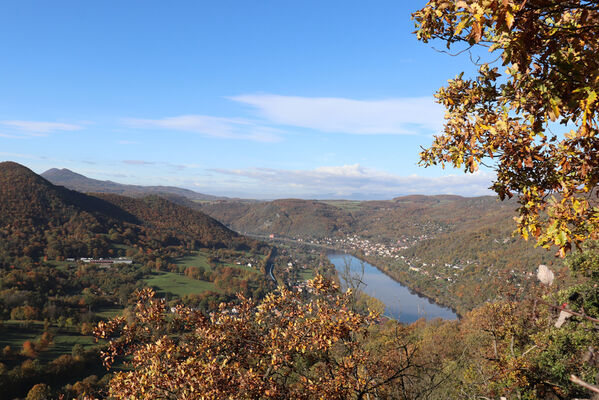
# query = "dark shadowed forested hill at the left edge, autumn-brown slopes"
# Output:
<box><xmin>0</xmin><ymin>162</ymin><xmax>256</xmax><ymax>263</ymax></box>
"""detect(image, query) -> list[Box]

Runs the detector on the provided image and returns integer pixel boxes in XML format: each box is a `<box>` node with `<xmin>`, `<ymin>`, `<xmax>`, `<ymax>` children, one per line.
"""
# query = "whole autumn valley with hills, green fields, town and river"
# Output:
<box><xmin>0</xmin><ymin>162</ymin><xmax>580</xmax><ymax>397</ymax></box>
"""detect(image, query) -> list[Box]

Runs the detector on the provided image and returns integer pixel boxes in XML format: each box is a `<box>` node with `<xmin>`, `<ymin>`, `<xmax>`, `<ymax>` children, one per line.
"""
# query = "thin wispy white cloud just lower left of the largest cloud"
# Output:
<box><xmin>124</xmin><ymin>115</ymin><xmax>280</xmax><ymax>142</ymax></box>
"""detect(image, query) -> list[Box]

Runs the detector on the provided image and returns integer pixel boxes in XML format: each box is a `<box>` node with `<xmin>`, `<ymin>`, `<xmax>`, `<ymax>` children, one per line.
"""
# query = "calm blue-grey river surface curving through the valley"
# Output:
<box><xmin>328</xmin><ymin>253</ymin><xmax>457</xmax><ymax>323</ymax></box>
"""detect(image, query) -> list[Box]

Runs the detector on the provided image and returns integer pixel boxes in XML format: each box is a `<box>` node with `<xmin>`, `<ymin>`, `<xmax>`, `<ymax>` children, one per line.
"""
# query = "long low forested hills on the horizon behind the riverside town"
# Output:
<box><xmin>198</xmin><ymin>195</ymin><xmax>517</xmax><ymax>240</ymax></box>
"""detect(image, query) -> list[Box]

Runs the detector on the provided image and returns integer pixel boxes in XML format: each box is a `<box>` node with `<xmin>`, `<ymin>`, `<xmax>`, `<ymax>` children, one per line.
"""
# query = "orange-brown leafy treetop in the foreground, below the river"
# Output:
<box><xmin>96</xmin><ymin>276</ymin><xmax>416</xmax><ymax>399</ymax></box>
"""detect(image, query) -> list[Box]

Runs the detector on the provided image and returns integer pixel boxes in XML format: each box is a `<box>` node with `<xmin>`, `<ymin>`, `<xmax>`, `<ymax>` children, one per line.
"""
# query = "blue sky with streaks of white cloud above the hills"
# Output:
<box><xmin>0</xmin><ymin>0</ymin><xmax>494</xmax><ymax>199</ymax></box>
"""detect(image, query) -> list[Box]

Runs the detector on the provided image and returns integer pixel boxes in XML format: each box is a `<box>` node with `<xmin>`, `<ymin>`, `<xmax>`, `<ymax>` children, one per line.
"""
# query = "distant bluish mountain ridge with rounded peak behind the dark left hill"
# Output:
<box><xmin>41</xmin><ymin>168</ymin><xmax>225</xmax><ymax>201</ymax></box>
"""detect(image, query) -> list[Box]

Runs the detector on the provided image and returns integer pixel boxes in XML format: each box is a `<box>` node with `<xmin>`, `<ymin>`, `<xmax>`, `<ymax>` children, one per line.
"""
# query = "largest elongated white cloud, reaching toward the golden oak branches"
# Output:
<box><xmin>230</xmin><ymin>94</ymin><xmax>444</xmax><ymax>135</ymax></box>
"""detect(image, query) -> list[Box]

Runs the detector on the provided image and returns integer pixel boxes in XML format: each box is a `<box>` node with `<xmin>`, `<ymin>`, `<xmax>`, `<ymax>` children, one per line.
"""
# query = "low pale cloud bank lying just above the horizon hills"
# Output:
<box><xmin>211</xmin><ymin>164</ymin><xmax>494</xmax><ymax>198</ymax></box>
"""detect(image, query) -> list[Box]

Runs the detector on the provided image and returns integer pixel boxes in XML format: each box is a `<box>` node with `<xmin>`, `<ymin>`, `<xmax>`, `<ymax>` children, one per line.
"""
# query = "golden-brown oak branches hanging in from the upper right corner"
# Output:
<box><xmin>413</xmin><ymin>0</ymin><xmax>599</xmax><ymax>256</ymax></box>
